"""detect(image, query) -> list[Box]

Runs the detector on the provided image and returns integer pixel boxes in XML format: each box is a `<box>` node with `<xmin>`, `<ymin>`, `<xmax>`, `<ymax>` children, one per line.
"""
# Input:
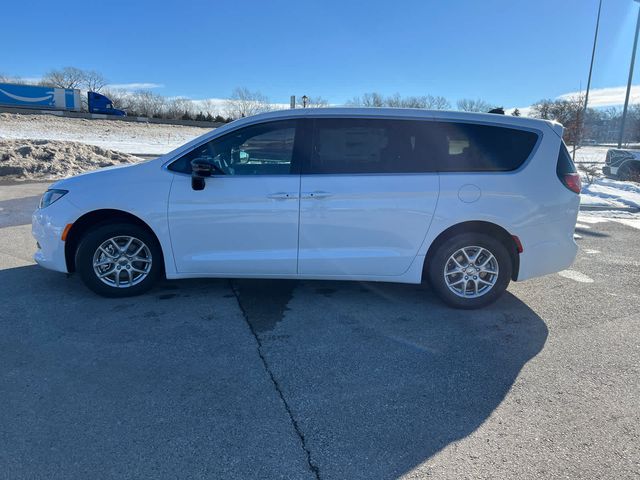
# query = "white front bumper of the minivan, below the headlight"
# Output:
<box><xmin>31</xmin><ymin>198</ymin><xmax>76</xmax><ymax>273</ymax></box>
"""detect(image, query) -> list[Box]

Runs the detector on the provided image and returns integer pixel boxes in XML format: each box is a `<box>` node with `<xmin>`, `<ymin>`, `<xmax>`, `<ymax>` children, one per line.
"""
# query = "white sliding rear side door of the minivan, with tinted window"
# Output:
<box><xmin>298</xmin><ymin>118</ymin><xmax>439</xmax><ymax>277</ymax></box>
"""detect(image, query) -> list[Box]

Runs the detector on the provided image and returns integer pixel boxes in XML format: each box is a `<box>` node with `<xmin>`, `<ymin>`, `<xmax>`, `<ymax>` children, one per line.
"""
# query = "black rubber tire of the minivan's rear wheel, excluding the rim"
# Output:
<box><xmin>427</xmin><ymin>233</ymin><xmax>513</xmax><ymax>310</ymax></box>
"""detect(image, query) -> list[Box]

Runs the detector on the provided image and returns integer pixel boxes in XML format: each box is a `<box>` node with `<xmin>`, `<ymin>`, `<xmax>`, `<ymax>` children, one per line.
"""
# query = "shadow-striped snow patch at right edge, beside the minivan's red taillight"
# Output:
<box><xmin>580</xmin><ymin>178</ymin><xmax>640</xmax><ymax>209</ymax></box>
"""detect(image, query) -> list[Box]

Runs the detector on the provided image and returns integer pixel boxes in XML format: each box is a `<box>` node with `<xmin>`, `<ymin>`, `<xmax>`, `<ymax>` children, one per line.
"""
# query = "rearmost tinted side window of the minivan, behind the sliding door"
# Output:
<box><xmin>424</xmin><ymin>122</ymin><xmax>538</xmax><ymax>172</ymax></box>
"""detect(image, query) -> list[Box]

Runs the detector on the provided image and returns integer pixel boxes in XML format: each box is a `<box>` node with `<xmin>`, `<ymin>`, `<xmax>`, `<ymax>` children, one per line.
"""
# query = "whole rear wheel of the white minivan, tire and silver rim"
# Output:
<box><xmin>428</xmin><ymin>233</ymin><xmax>512</xmax><ymax>309</ymax></box>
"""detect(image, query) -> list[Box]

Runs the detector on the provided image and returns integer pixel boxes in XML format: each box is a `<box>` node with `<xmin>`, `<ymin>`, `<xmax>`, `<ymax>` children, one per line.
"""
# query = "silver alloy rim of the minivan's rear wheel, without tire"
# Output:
<box><xmin>444</xmin><ymin>246</ymin><xmax>500</xmax><ymax>298</ymax></box>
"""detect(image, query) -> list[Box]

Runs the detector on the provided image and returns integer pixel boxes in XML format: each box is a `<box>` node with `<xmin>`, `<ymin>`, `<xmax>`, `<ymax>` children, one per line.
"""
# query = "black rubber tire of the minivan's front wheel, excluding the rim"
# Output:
<box><xmin>76</xmin><ymin>223</ymin><xmax>164</xmax><ymax>297</ymax></box>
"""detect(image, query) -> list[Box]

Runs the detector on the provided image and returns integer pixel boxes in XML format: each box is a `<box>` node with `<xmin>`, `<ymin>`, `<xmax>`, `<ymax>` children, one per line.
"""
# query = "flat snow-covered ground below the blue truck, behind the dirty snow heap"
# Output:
<box><xmin>0</xmin><ymin>113</ymin><xmax>211</xmax><ymax>155</ymax></box>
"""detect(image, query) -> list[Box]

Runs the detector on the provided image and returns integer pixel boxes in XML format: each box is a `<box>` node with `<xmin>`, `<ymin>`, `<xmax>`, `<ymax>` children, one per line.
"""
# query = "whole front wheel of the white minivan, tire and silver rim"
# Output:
<box><xmin>76</xmin><ymin>223</ymin><xmax>162</xmax><ymax>297</ymax></box>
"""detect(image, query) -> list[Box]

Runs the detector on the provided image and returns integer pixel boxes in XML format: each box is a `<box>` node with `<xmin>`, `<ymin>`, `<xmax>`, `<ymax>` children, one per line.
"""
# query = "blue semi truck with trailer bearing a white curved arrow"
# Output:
<box><xmin>0</xmin><ymin>83</ymin><xmax>126</xmax><ymax>116</ymax></box>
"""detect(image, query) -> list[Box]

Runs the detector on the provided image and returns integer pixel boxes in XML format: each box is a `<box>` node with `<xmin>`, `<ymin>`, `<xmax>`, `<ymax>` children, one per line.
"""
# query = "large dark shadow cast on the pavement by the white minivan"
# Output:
<box><xmin>0</xmin><ymin>266</ymin><xmax>548</xmax><ymax>479</ymax></box>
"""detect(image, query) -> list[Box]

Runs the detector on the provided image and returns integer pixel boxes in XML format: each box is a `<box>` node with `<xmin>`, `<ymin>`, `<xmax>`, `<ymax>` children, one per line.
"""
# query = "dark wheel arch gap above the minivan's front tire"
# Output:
<box><xmin>64</xmin><ymin>209</ymin><xmax>165</xmax><ymax>273</ymax></box>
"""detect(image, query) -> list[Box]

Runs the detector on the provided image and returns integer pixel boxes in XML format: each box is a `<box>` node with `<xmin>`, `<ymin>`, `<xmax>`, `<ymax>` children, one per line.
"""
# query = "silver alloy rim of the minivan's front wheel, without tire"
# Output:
<box><xmin>93</xmin><ymin>235</ymin><xmax>153</xmax><ymax>288</ymax></box>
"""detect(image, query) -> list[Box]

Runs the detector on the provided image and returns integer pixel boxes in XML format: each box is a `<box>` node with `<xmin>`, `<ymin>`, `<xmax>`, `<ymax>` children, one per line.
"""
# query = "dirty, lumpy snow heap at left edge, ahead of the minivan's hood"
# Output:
<box><xmin>0</xmin><ymin>140</ymin><xmax>140</xmax><ymax>180</ymax></box>
